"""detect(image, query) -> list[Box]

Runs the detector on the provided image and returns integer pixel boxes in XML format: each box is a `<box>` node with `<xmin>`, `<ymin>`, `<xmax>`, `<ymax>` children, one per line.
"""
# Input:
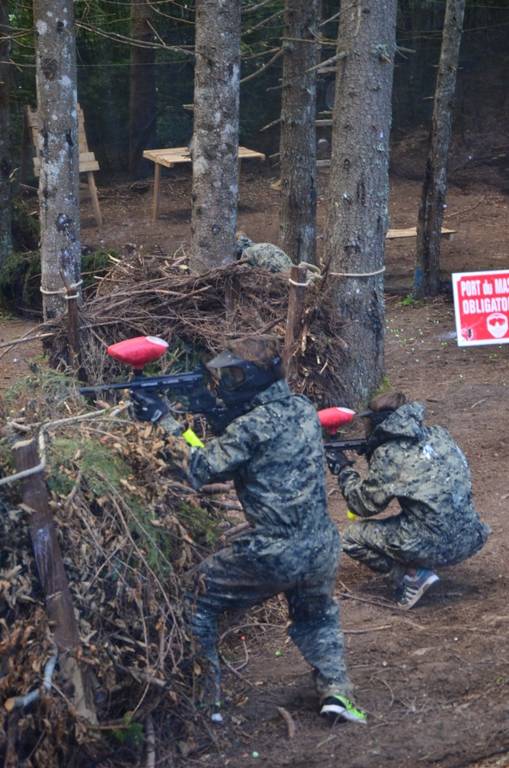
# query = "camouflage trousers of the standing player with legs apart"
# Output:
<box><xmin>189</xmin><ymin>529</ymin><xmax>350</xmax><ymax>704</ymax></box>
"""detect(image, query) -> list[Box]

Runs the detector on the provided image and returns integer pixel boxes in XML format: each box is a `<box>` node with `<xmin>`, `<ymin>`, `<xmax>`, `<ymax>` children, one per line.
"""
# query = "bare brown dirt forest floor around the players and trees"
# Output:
<box><xmin>0</xmin><ymin>166</ymin><xmax>509</xmax><ymax>768</ymax></box>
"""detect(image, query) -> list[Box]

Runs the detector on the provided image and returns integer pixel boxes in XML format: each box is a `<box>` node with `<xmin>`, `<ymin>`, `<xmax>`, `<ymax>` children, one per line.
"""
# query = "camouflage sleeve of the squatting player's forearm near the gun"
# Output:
<box><xmin>338</xmin><ymin>449</ymin><xmax>394</xmax><ymax>517</ymax></box>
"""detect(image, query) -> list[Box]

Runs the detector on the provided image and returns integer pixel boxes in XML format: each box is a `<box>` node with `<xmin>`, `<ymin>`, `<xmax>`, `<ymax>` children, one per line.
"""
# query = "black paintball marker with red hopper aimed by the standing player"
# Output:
<box><xmin>80</xmin><ymin>336</ymin><xmax>228</xmax><ymax>425</ymax></box>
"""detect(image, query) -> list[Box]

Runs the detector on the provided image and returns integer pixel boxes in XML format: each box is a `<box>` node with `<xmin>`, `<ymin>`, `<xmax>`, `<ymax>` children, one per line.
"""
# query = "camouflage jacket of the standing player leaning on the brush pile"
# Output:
<box><xmin>188</xmin><ymin>381</ymin><xmax>334</xmax><ymax>540</ymax></box>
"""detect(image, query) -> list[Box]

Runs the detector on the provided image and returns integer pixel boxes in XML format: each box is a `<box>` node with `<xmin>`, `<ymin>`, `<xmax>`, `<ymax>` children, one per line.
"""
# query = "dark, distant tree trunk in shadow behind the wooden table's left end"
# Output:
<box><xmin>129</xmin><ymin>0</ymin><xmax>157</xmax><ymax>176</ymax></box>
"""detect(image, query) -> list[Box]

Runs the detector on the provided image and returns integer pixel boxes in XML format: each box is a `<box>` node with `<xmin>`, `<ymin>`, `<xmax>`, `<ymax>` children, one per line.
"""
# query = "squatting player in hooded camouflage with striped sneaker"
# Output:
<box><xmin>328</xmin><ymin>392</ymin><xmax>490</xmax><ymax>609</ymax></box>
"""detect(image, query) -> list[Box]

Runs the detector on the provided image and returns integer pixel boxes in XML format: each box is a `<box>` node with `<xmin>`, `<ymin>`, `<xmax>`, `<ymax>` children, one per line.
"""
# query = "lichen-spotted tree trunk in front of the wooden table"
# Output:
<box><xmin>191</xmin><ymin>0</ymin><xmax>240</xmax><ymax>270</ymax></box>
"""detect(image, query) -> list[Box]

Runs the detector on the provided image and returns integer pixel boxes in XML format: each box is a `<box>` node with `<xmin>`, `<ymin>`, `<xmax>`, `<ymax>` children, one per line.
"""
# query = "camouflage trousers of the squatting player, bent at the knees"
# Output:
<box><xmin>343</xmin><ymin>514</ymin><xmax>489</xmax><ymax>573</ymax></box>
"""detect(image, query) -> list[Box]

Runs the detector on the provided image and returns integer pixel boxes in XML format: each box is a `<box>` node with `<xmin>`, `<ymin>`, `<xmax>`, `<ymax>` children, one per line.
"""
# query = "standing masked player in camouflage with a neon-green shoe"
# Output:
<box><xmin>132</xmin><ymin>337</ymin><xmax>366</xmax><ymax>723</ymax></box>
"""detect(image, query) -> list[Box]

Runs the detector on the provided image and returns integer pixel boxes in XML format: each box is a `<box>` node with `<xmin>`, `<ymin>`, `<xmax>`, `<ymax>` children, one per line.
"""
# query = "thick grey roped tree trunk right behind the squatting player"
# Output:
<box><xmin>325</xmin><ymin>0</ymin><xmax>397</xmax><ymax>407</ymax></box>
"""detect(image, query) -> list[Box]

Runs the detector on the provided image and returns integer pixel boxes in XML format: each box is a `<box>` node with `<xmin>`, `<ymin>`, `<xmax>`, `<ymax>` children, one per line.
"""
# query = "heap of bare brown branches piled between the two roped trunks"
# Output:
<box><xmin>48</xmin><ymin>252</ymin><xmax>341</xmax><ymax>405</ymax></box>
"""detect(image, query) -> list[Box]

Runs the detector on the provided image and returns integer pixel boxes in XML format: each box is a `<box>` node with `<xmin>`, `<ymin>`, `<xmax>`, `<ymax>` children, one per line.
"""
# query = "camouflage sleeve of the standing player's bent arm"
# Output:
<box><xmin>188</xmin><ymin>418</ymin><xmax>263</xmax><ymax>488</ymax></box>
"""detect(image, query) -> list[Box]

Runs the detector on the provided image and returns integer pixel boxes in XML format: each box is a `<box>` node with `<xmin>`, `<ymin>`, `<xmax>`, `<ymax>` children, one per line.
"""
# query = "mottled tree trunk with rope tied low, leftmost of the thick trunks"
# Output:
<box><xmin>34</xmin><ymin>0</ymin><xmax>81</xmax><ymax>320</ymax></box>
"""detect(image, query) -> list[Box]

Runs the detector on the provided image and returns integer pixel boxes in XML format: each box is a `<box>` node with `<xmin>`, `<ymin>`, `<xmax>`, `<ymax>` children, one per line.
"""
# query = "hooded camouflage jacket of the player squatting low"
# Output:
<box><xmin>338</xmin><ymin>403</ymin><xmax>484</xmax><ymax>535</ymax></box>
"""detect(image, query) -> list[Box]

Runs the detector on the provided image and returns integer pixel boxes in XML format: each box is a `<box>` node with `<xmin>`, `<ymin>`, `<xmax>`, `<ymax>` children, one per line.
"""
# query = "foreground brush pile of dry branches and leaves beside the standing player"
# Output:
<box><xmin>0</xmin><ymin>372</ymin><xmax>242</xmax><ymax>768</ymax></box>
